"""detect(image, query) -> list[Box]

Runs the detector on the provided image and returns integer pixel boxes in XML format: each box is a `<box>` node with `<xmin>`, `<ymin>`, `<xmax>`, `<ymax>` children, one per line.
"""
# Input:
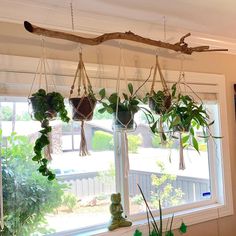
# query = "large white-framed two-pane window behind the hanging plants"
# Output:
<box><xmin>0</xmin><ymin>72</ymin><xmax>232</xmax><ymax>235</ymax></box>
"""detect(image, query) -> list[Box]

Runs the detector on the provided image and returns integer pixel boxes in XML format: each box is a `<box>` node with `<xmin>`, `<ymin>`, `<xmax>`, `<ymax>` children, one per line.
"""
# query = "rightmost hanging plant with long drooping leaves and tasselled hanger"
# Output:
<box><xmin>162</xmin><ymin>81</ymin><xmax>220</xmax><ymax>169</ymax></box>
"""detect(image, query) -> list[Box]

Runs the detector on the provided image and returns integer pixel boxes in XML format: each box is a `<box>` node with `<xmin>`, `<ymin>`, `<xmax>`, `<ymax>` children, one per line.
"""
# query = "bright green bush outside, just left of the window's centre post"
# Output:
<box><xmin>92</xmin><ymin>130</ymin><xmax>114</xmax><ymax>151</ymax></box>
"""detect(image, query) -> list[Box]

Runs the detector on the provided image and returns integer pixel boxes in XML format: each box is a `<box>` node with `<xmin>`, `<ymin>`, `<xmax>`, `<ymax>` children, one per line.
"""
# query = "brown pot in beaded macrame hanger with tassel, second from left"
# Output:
<box><xmin>69</xmin><ymin>53</ymin><xmax>97</xmax><ymax>156</ymax></box>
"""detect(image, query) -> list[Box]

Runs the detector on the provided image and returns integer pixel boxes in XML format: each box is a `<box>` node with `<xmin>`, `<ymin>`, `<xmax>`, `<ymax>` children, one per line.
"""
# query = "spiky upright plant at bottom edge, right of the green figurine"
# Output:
<box><xmin>134</xmin><ymin>184</ymin><xmax>187</xmax><ymax>236</ymax></box>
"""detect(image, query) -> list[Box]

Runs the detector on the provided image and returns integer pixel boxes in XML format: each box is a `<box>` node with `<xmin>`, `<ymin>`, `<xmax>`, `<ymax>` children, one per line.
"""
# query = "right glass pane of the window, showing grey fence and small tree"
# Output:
<box><xmin>128</xmin><ymin>107</ymin><xmax>211</xmax><ymax>214</ymax></box>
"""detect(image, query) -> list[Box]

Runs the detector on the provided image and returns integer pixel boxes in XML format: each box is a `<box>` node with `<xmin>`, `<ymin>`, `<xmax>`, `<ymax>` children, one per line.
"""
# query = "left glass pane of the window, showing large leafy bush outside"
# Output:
<box><xmin>1</xmin><ymin>102</ymin><xmax>115</xmax><ymax>236</ymax></box>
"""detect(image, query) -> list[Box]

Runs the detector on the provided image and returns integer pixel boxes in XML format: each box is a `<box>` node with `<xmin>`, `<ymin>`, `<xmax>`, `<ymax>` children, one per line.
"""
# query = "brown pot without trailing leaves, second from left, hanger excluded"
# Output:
<box><xmin>69</xmin><ymin>96</ymin><xmax>97</xmax><ymax>121</ymax></box>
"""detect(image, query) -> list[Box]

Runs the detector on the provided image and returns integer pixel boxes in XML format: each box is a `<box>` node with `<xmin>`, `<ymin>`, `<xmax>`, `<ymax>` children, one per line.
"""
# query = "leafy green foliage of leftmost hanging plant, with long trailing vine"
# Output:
<box><xmin>29</xmin><ymin>89</ymin><xmax>70</xmax><ymax>180</ymax></box>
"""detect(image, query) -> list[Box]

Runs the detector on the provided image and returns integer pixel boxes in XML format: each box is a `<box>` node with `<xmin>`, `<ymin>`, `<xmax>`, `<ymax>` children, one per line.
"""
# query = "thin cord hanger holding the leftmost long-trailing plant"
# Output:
<box><xmin>28</xmin><ymin>37</ymin><xmax>57</xmax><ymax>161</ymax></box>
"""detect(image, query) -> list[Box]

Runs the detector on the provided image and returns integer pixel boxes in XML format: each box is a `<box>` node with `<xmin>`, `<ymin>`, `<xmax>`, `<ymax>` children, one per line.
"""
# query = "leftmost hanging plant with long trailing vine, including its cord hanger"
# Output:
<box><xmin>28</xmin><ymin>39</ymin><xmax>69</xmax><ymax>180</ymax></box>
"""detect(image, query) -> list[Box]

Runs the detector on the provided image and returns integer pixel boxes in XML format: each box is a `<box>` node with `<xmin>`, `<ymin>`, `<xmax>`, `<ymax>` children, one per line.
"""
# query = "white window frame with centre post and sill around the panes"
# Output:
<box><xmin>0</xmin><ymin>68</ymin><xmax>233</xmax><ymax>236</ymax></box>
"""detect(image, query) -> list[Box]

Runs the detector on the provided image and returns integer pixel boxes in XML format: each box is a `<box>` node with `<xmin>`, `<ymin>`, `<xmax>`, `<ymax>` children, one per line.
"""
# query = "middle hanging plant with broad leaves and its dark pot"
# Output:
<box><xmin>98</xmin><ymin>83</ymin><xmax>154</xmax><ymax>128</ymax></box>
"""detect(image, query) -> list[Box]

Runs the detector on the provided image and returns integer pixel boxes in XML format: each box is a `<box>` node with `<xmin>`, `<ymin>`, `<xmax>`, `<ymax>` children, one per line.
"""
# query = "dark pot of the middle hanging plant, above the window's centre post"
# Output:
<box><xmin>114</xmin><ymin>111</ymin><xmax>135</xmax><ymax>130</ymax></box>
